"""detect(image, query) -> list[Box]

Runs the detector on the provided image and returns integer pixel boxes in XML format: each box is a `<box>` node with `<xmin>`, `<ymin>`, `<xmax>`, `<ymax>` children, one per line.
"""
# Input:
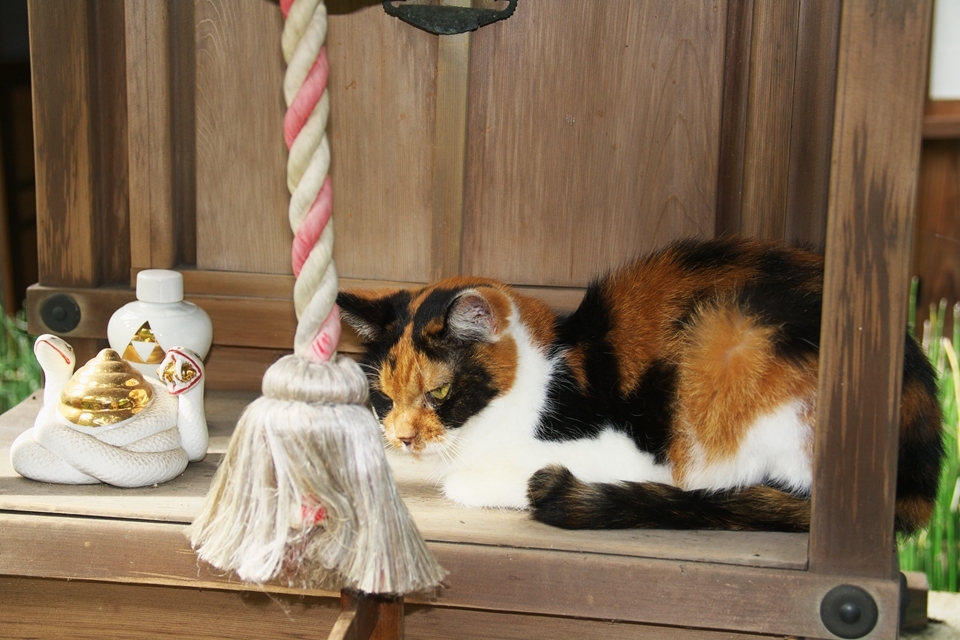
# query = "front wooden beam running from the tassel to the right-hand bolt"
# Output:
<box><xmin>424</xmin><ymin>543</ymin><xmax>899</xmax><ymax>638</ymax></box>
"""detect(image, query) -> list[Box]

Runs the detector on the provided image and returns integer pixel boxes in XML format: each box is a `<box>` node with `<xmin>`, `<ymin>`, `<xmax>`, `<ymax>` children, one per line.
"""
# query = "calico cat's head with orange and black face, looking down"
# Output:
<box><xmin>337</xmin><ymin>278</ymin><xmax>517</xmax><ymax>455</ymax></box>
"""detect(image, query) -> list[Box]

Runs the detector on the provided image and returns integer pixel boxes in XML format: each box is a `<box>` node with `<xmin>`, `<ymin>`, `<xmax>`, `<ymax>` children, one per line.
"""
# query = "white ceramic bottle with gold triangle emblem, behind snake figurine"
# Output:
<box><xmin>107</xmin><ymin>269</ymin><xmax>213</xmax><ymax>378</ymax></box>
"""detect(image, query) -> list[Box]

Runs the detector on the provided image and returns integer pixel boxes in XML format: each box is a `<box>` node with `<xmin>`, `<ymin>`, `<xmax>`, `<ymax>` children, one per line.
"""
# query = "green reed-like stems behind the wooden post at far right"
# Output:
<box><xmin>899</xmin><ymin>278</ymin><xmax>960</xmax><ymax>592</ymax></box>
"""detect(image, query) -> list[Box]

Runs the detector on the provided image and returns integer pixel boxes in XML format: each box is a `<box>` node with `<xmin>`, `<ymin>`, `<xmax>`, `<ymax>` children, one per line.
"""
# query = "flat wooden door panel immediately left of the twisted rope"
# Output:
<box><xmin>194</xmin><ymin>0</ymin><xmax>293</xmax><ymax>274</ymax></box>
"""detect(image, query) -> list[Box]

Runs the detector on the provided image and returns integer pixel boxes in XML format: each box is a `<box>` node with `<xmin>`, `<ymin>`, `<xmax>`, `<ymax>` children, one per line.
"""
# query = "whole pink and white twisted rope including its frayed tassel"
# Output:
<box><xmin>187</xmin><ymin>0</ymin><xmax>445</xmax><ymax>594</ymax></box>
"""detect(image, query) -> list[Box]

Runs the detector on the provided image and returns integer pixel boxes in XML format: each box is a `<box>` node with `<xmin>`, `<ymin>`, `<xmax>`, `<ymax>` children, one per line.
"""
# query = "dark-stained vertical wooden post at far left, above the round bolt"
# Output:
<box><xmin>28</xmin><ymin>0</ymin><xmax>99</xmax><ymax>287</ymax></box>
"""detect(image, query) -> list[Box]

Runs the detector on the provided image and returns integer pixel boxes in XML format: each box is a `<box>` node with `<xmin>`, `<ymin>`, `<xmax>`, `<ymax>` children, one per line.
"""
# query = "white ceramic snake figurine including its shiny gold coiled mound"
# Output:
<box><xmin>10</xmin><ymin>334</ymin><xmax>209</xmax><ymax>487</ymax></box>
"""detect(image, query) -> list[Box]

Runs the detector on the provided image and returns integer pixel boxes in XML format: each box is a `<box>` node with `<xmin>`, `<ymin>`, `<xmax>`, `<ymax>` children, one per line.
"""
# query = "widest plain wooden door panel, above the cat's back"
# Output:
<box><xmin>463</xmin><ymin>0</ymin><xmax>726</xmax><ymax>286</ymax></box>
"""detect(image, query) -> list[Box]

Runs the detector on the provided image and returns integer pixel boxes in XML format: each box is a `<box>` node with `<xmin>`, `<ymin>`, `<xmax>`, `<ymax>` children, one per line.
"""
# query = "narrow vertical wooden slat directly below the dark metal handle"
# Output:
<box><xmin>431</xmin><ymin>0</ymin><xmax>472</xmax><ymax>280</ymax></box>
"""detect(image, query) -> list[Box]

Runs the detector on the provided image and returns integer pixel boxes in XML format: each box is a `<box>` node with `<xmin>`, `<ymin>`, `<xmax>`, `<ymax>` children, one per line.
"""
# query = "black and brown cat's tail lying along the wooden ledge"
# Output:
<box><xmin>528</xmin><ymin>466</ymin><xmax>810</xmax><ymax>531</ymax></box>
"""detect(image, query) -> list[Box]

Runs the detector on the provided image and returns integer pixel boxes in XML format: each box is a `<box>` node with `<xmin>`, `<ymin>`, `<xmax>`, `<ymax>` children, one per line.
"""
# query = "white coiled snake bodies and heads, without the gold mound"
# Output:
<box><xmin>10</xmin><ymin>334</ymin><xmax>208</xmax><ymax>487</ymax></box>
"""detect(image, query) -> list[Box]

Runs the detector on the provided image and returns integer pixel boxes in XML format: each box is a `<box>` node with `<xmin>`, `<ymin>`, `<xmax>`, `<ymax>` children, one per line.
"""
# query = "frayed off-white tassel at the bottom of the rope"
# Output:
<box><xmin>187</xmin><ymin>356</ymin><xmax>446</xmax><ymax>594</ymax></box>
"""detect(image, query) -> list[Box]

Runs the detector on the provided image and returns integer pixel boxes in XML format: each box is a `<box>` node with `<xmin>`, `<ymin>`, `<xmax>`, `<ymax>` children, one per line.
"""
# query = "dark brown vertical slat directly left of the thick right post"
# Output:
<box><xmin>784</xmin><ymin>0</ymin><xmax>841</xmax><ymax>245</ymax></box>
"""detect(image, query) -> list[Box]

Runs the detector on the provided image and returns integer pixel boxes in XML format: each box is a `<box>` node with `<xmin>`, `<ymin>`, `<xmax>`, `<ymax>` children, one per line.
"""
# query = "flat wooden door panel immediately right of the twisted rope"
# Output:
<box><xmin>327</xmin><ymin>1</ymin><xmax>436</xmax><ymax>282</ymax></box>
